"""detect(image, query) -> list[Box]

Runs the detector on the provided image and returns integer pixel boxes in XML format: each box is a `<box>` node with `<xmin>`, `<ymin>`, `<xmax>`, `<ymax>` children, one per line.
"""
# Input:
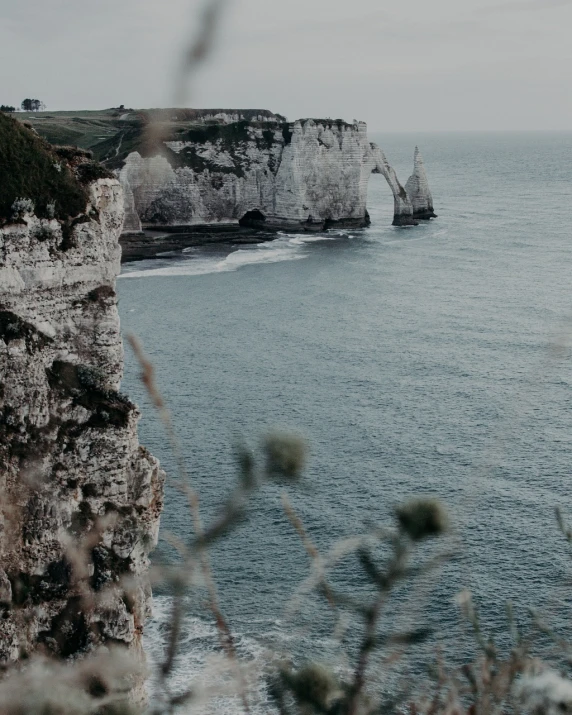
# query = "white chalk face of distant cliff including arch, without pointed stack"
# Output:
<box><xmin>119</xmin><ymin>119</ymin><xmax>424</xmax><ymax>231</ymax></box>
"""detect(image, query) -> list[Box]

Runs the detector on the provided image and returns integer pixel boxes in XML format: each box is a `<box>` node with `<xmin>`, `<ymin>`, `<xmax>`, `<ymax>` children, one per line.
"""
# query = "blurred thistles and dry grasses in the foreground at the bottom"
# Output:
<box><xmin>0</xmin><ymin>341</ymin><xmax>572</xmax><ymax>715</ymax></box>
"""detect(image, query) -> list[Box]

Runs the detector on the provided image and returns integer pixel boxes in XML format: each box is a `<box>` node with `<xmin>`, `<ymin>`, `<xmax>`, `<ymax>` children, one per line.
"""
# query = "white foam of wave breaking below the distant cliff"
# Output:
<box><xmin>120</xmin><ymin>234</ymin><xmax>338</xmax><ymax>278</ymax></box>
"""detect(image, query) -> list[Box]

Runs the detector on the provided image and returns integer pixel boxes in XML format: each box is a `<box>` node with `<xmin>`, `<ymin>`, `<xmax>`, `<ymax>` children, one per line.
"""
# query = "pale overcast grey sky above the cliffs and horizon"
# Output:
<box><xmin>0</xmin><ymin>0</ymin><xmax>572</xmax><ymax>132</ymax></box>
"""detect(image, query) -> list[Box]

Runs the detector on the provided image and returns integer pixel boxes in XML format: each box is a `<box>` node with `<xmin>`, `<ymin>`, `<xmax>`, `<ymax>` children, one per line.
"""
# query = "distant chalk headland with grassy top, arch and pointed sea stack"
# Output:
<box><xmin>11</xmin><ymin>108</ymin><xmax>433</xmax><ymax>238</ymax></box>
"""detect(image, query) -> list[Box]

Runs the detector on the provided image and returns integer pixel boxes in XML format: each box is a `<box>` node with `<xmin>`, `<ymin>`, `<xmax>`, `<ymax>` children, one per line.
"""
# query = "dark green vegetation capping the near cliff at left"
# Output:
<box><xmin>0</xmin><ymin>112</ymin><xmax>87</xmax><ymax>220</ymax></box>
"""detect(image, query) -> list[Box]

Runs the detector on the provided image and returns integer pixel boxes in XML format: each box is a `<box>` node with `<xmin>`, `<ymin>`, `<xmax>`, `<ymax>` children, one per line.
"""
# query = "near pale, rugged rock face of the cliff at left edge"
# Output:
<box><xmin>0</xmin><ymin>179</ymin><xmax>164</xmax><ymax>688</ymax></box>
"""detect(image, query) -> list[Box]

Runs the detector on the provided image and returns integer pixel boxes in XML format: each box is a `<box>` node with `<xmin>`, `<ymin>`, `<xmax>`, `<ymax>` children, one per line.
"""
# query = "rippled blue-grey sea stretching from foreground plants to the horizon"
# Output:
<box><xmin>118</xmin><ymin>133</ymin><xmax>572</xmax><ymax>713</ymax></box>
